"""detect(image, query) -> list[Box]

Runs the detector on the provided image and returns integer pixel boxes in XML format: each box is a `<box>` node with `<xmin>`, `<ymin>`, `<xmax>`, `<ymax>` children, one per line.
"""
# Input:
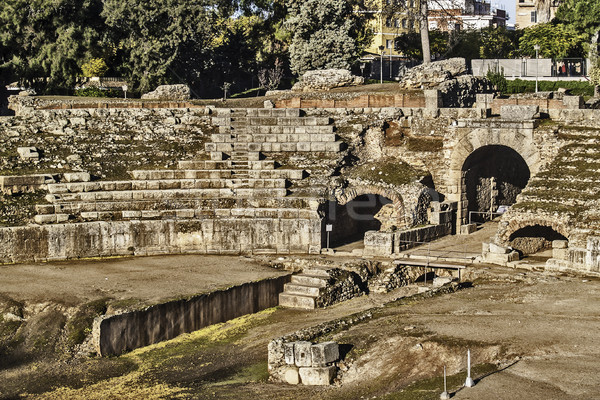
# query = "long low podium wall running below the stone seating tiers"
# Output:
<box><xmin>0</xmin><ymin>218</ymin><xmax>321</xmax><ymax>263</ymax></box>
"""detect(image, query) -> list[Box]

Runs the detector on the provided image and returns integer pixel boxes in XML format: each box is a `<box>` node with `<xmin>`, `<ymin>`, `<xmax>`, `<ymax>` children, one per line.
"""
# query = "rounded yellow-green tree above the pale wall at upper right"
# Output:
<box><xmin>519</xmin><ymin>23</ymin><xmax>584</xmax><ymax>59</ymax></box>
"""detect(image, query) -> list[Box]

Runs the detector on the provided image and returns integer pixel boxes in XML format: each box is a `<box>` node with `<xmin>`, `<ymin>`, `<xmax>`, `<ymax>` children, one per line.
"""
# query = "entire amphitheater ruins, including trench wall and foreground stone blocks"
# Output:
<box><xmin>0</xmin><ymin>59</ymin><xmax>600</xmax><ymax>394</ymax></box>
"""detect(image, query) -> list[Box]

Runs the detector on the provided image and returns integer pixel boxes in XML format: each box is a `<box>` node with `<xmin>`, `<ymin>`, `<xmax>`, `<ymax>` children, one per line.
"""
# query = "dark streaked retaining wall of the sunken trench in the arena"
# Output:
<box><xmin>92</xmin><ymin>275</ymin><xmax>291</xmax><ymax>356</ymax></box>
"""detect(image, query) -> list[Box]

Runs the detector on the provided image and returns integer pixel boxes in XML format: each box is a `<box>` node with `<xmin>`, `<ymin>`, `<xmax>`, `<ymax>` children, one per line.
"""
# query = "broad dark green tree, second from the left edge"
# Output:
<box><xmin>102</xmin><ymin>0</ymin><xmax>233</xmax><ymax>92</ymax></box>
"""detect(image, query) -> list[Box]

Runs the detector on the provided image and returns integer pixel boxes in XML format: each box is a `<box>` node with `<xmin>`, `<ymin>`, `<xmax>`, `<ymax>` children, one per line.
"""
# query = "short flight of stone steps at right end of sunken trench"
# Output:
<box><xmin>279</xmin><ymin>267</ymin><xmax>330</xmax><ymax>310</ymax></box>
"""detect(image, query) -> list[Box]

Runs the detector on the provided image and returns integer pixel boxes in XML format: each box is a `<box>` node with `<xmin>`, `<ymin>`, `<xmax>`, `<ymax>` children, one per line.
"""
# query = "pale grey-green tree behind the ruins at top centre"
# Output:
<box><xmin>285</xmin><ymin>0</ymin><xmax>368</xmax><ymax>75</ymax></box>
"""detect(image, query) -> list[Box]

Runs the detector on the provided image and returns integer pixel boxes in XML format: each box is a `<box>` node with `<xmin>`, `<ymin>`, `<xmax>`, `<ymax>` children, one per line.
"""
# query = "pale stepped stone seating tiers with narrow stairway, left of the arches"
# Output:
<box><xmin>34</xmin><ymin>109</ymin><xmax>343</xmax><ymax>224</ymax></box>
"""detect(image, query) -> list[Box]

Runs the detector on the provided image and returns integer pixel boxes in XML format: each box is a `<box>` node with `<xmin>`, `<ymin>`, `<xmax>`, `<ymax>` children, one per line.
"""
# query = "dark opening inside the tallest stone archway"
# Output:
<box><xmin>462</xmin><ymin>145</ymin><xmax>531</xmax><ymax>222</ymax></box>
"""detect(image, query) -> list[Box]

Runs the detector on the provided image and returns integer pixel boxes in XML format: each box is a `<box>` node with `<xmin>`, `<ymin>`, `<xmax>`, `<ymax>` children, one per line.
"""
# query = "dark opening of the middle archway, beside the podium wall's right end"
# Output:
<box><xmin>321</xmin><ymin>194</ymin><xmax>392</xmax><ymax>248</ymax></box>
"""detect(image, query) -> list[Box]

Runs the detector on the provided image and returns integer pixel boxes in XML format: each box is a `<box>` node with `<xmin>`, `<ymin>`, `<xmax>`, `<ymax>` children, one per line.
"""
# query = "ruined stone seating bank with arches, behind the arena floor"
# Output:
<box><xmin>0</xmin><ymin>82</ymin><xmax>600</xmax><ymax>272</ymax></box>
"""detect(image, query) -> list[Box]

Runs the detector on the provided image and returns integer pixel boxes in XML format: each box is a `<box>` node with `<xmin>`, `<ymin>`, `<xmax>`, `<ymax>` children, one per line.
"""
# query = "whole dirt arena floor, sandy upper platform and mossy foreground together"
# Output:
<box><xmin>0</xmin><ymin>236</ymin><xmax>600</xmax><ymax>400</ymax></box>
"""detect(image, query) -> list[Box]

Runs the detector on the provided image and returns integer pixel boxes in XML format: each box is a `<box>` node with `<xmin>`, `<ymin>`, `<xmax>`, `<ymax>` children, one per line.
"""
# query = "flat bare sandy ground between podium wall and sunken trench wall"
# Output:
<box><xmin>0</xmin><ymin>255</ymin><xmax>284</xmax><ymax>305</ymax></box>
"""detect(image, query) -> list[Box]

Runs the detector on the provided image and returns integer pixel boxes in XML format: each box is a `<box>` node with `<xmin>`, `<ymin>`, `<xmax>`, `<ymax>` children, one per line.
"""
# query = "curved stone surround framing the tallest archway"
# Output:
<box><xmin>447</xmin><ymin>128</ymin><xmax>541</xmax><ymax>228</ymax></box>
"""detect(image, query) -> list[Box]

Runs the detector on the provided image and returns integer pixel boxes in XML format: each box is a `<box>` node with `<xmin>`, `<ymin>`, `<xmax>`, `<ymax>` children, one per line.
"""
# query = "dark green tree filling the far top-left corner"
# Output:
<box><xmin>0</xmin><ymin>0</ymin><xmax>106</xmax><ymax>92</ymax></box>
